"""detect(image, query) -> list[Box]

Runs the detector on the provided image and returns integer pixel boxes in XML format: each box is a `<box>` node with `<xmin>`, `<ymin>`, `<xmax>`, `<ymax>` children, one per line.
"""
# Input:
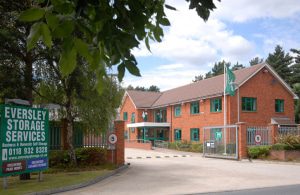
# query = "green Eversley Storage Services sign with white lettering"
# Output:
<box><xmin>0</xmin><ymin>105</ymin><xmax>49</xmax><ymax>176</ymax></box>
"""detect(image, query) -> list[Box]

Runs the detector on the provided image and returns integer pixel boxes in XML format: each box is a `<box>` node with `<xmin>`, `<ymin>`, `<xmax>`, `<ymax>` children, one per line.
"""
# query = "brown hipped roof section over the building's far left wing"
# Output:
<box><xmin>126</xmin><ymin>90</ymin><xmax>162</xmax><ymax>108</ymax></box>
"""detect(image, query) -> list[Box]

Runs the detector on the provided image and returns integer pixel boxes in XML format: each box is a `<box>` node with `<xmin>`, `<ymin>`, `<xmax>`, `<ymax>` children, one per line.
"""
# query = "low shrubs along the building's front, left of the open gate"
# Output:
<box><xmin>168</xmin><ymin>140</ymin><xmax>203</xmax><ymax>153</ymax></box>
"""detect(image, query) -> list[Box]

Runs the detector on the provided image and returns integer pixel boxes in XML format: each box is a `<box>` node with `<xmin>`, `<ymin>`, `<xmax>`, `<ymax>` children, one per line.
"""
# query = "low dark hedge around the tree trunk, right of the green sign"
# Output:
<box><xmin>49</xmin><ymin>147</ymin><xmax>107</xmax><ymax>168</ymax></box>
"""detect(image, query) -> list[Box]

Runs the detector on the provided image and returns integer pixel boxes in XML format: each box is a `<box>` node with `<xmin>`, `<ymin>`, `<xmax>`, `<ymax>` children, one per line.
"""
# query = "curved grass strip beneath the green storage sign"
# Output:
<box><xmin>0</xmin><ymin>169</ymin><xmax>111</xmax><ymax>195</ymax></box>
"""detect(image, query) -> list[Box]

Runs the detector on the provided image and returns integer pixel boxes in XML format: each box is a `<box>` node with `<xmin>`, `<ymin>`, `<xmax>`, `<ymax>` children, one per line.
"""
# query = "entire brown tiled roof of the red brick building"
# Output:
<box><xmin>123</xmin><ymin>63</ymin><xmax>298</xmax><ymax>108</ymax></box>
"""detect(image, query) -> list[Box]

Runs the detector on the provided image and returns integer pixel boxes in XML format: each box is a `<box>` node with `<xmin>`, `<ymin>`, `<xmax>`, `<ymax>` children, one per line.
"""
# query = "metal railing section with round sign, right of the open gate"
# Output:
<box><xmin>247</xmin><ymin>126</ymin><xmax>272</xmax><ymax>146</ymax></box>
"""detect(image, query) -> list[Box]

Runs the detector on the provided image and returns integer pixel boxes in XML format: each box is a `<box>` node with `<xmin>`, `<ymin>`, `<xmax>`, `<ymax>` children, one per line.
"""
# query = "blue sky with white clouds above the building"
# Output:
<box><xmin>118</xmin><ymin>0</ymin><xmax>300</xmax><ymax>91</ymax></box>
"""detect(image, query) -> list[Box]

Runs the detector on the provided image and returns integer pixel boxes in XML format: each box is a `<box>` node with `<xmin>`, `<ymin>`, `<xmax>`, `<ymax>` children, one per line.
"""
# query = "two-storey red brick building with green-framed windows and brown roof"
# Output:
<box><xmin>120</xmin><ymin>63</ymin><xmax>298</xmax><ymax>142</ymax></box>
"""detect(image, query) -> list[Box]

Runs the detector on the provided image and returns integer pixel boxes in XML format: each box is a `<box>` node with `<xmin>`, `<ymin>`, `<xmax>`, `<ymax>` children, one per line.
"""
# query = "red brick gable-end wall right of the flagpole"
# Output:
<box><xmin>228</xmin><ymin>70</ymin><xmax>294</xmax><ymax>126</ymax></box>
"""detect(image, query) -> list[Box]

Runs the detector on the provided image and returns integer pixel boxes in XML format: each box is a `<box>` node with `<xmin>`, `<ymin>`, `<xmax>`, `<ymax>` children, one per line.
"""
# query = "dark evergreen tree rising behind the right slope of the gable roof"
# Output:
<box><xmin>266</xmin><ymin>45</ymin><xmax>293</xmax><ymax>84</ymax></box>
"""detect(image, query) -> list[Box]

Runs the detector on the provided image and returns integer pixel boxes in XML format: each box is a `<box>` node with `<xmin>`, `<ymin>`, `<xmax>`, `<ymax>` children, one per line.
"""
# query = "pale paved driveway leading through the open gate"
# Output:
<box><xmin>58</xmin><ymin>149</ymin><xmax>300</xmax><ymax>195</ymax></box>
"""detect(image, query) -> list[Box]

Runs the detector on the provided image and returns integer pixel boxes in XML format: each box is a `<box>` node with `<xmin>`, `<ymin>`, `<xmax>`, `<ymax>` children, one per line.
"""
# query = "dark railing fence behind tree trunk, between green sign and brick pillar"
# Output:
<box><xmin>49</xmin><ymin>121</ymin><xmax>108</xmax><ymax>150</ymax></box>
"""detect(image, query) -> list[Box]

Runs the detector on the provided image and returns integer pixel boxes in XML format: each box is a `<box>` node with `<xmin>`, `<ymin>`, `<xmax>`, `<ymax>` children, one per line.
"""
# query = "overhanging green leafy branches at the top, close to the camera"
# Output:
<box><xmin>19</xmin><ymin>0</ymin><xmax>216</xmax><ymax>88</ymax></box>
